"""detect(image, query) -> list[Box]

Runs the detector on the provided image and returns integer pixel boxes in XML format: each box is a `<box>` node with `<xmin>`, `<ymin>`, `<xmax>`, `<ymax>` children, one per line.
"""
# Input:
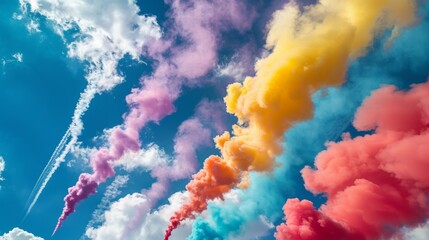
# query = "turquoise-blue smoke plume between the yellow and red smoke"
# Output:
<box><xmin>190</xmin><ymin>1</ymin><xmax>429</xmax><ymax>240</ymax></box>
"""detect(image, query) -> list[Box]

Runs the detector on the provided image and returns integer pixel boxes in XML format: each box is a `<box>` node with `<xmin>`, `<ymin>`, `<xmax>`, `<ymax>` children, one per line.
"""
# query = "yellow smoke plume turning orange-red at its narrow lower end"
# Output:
<box><xmin>165</xmin><ymin>0</ymin><xmax>415</xmax><ymax>239</ymax></box>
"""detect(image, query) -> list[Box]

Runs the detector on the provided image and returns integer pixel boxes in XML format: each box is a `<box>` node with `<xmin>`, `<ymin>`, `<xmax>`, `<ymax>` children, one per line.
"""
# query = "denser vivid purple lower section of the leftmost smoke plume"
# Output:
<box><xmin>54</xmin><ymin>81</ymin><xmax>174</xmax><ymax>234</ymax></box>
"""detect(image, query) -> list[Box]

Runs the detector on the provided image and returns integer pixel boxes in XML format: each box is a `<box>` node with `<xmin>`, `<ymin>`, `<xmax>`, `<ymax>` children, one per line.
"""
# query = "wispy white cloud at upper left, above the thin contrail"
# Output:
<box><xmin>20</xmin><ymin>0</ymin><xmax>160</xmax><ymax>91</ymax></box>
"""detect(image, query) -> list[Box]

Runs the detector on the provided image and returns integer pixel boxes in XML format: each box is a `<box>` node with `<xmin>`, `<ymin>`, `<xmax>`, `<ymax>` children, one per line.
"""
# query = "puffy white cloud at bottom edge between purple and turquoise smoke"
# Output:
<box><xmin>86</xmin><ymin>192</ymin><xmax>192</xmax><ymax>240</ymax></box>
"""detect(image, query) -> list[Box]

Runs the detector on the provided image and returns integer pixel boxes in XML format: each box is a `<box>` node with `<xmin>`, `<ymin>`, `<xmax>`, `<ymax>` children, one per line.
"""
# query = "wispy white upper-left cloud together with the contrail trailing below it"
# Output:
<box><xmin>20</xmin><ymin>0</ymin><xmax>160</xmax><ymax>218</ymax></box>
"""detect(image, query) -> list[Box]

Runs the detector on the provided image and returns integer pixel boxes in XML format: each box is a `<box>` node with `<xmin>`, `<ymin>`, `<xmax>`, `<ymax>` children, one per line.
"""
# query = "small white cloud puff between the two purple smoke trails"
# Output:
<box><xmin>115</xmin><ymin>144</ymin><xmax>169</xmax><ymax>171</ymax></box>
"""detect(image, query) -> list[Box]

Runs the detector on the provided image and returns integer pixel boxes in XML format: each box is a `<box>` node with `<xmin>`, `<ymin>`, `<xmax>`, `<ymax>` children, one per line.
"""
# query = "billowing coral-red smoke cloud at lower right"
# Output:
<box><xmin>276</xmin><ymin>83</ymin><xmax>429</xmax><ymax>240</ymax></box>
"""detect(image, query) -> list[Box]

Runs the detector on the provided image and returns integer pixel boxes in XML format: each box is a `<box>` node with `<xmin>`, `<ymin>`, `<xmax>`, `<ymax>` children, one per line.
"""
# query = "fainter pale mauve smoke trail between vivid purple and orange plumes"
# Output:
<box><xmin>121</xmin><ymin>100</ymin><xmax>225</xmax><ymax>239</ymax></box>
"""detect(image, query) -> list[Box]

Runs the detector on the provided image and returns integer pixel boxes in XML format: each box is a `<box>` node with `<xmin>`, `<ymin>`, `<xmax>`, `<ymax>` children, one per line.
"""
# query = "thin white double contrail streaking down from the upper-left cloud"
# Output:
<box><xmin>23</xmin><ymin>84</ymin><xmax>97</xmax><ymax>219</ymax></box>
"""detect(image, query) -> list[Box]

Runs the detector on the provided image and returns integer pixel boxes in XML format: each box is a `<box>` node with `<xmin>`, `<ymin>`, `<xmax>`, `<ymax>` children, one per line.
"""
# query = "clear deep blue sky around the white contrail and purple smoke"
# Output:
<box><xmin>0</xmin><ymin>1</ymin><xmax>247</xmax><ymax>239</ymax></box>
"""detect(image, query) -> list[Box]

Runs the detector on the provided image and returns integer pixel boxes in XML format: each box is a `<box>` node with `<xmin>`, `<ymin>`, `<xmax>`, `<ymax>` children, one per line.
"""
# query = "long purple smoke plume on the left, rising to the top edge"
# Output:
<box><xmin>54</xmin><ymin>0</ymin><xmax>253</xmax><ymax>232</ymax></box>
